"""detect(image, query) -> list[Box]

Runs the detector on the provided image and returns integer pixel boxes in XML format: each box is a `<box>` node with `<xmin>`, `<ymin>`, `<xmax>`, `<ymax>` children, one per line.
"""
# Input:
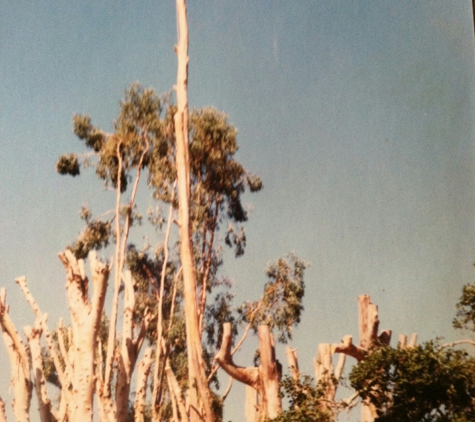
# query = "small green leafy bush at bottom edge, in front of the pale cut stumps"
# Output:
<box><xmin>271</xmin><ymin>376</ymin><xmax>333</xmax><ymax>422</ymax></box>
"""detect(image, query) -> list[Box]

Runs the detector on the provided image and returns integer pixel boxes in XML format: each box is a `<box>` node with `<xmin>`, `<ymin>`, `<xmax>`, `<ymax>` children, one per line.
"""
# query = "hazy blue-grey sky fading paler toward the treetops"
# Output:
<box><xmin>0</xmin><ymin>0</ymin><xmax>475</xmax><ymax>422</ymax></box>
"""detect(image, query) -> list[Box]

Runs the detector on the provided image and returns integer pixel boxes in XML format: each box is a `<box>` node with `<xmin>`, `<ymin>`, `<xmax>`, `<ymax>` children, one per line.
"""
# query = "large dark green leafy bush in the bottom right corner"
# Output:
<box><xmin>350</xmin><ymin>342</ymin><xmax>475</xmax><ymax>422</ymax></box>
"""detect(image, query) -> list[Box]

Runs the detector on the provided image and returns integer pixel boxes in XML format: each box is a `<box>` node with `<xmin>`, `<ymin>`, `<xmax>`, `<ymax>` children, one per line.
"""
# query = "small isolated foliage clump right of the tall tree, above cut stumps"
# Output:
<box><xmin>238</xmin><ymin>253</ymin><xmax>308</xmax><ymax>343</ymax></box>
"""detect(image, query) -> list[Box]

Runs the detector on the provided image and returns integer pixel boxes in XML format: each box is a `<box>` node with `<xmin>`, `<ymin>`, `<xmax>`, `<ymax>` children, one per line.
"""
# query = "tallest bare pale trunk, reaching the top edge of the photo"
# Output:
<box><xmin>175</xmin><ymin>0</ymin><xmax>214</xmax><ymax>422</ymax></box>
